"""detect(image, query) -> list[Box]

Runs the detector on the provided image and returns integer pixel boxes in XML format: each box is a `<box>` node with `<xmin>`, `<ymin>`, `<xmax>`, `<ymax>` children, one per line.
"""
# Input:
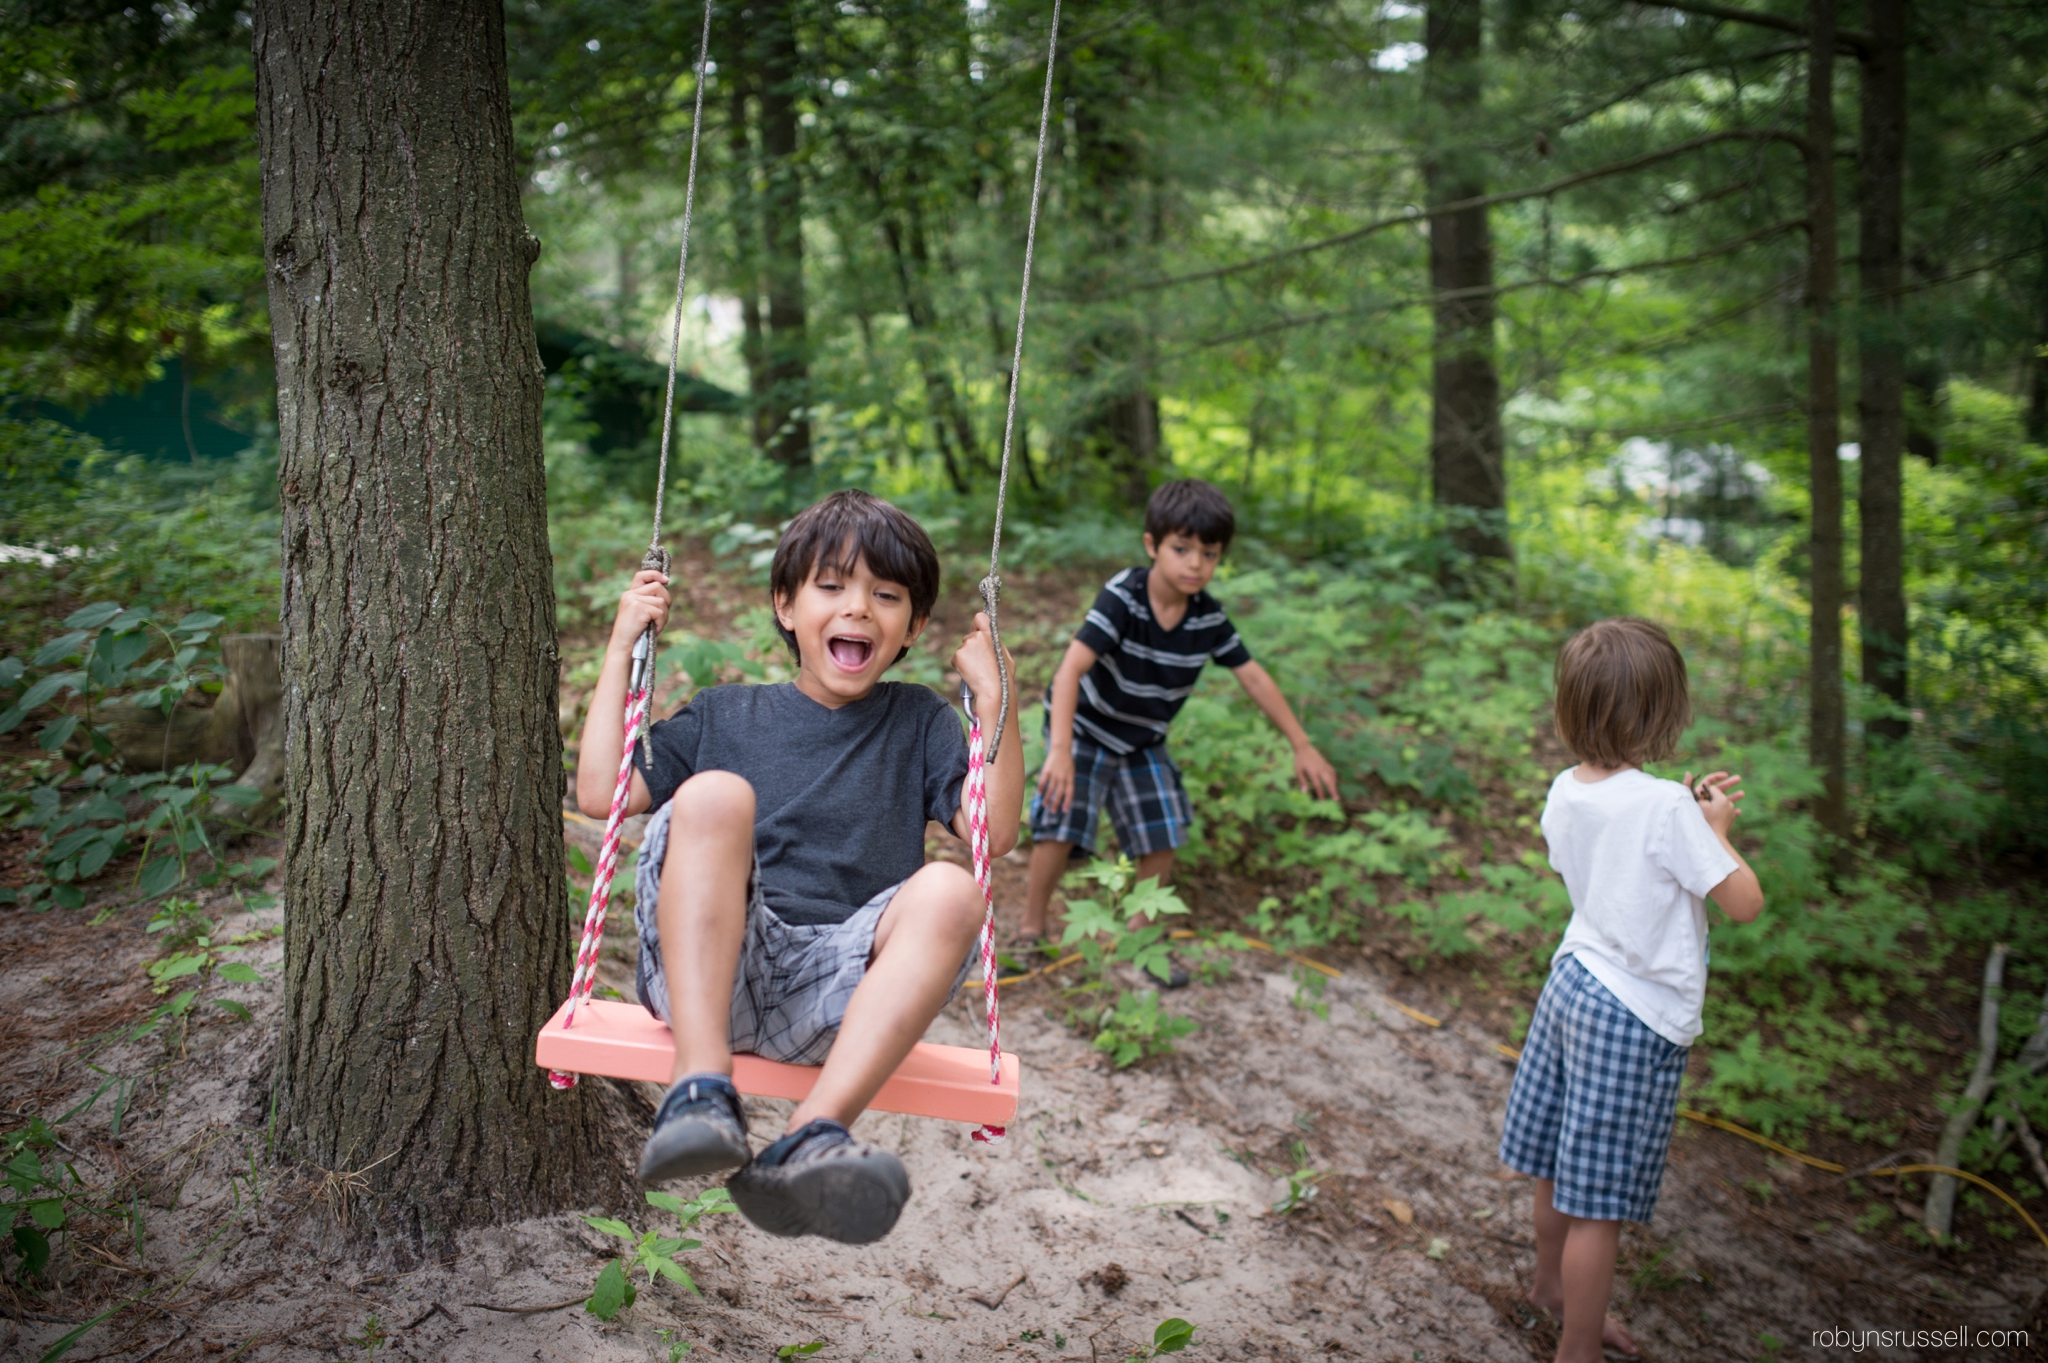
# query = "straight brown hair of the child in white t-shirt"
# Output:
<box><xmin>1554</xmin><ymin>616</ymin><xmax>1692</xmax><ymax>767</ymax></box>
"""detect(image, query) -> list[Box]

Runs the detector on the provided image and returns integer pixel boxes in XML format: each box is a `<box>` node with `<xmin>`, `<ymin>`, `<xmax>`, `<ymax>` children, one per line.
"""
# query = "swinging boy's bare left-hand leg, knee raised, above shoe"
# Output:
<box><xmin>655</xmin><ymin>772</ymin><xmax>754</xmax><ymax>1081</ymax></box>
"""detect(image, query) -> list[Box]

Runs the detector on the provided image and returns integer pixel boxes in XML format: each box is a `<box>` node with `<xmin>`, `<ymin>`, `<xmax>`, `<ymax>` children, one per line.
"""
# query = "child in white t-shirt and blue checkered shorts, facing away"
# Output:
<box><xmin>1501</xmin><ymin>618</ymin><xmax>1763</xmax><ymax>1363</ymax></box>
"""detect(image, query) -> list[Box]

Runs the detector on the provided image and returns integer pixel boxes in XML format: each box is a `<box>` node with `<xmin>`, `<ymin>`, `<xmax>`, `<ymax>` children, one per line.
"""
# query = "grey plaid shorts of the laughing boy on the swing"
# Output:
<box><xmin>633</xmin><ymin>804</ymin><xmax>975</xmax><ymax>1064</ymax></box>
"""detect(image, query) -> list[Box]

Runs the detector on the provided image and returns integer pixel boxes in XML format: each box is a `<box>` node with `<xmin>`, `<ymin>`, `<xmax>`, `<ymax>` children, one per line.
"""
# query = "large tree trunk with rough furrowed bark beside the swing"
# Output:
<box><xmin>256</xmin><ymin>0</ymin><xmax>623</xmax><ymax>1244</ymax></box>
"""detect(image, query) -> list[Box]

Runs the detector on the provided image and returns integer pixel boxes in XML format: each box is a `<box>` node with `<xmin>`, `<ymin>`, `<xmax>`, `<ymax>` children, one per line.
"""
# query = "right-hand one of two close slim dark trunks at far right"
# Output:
<box><xmin>1855</xmin><ymin>0</ymin><xmax>1909</xmax><ymax>741</ymax></box>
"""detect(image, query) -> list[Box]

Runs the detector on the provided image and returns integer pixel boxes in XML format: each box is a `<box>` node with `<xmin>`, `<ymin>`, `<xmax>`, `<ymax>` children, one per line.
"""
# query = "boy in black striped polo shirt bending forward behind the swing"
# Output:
<box><xmin>1020</xmin><ymin>479</ymin><xmax>1337</xmax><ymax>949</ymax></box>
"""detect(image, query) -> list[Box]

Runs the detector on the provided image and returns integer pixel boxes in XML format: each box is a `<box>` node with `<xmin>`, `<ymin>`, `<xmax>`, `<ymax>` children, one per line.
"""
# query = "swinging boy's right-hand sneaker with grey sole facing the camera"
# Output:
<box><xmin>725</xmin><ymin>1117</ymin><xmax>909</xmax><ymax>1244</ymax></box>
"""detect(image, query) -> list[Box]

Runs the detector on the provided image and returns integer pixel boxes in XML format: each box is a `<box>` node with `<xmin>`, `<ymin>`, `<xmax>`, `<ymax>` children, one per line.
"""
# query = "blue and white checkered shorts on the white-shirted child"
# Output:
<box><xmin>1501</xmin><ymin>956</ymin><xmax>1692</xmax><ymax>1222</ymax></box>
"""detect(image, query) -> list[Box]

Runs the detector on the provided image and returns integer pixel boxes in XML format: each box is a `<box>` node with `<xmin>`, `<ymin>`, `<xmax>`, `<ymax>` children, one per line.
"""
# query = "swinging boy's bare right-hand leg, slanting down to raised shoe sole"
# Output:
<box><xmin>788</xmin><ymin>862</ymin><xmax>981</xmax><ymax>1132</ymax></box>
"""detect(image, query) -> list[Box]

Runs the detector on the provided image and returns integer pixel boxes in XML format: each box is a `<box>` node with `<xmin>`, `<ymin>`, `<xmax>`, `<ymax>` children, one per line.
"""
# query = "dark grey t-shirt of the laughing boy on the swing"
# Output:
<box><xmin>633</xmin><ymin>682</ymin><xmax>967</xmax><ymax>923</ymax></box>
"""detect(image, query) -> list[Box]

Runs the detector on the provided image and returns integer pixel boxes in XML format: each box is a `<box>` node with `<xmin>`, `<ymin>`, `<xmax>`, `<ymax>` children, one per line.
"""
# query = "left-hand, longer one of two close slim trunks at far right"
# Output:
<box><xmin>1806</xmin><ymin>0</ymin><xmax>1849</xmax><ymax>835</ymax></box>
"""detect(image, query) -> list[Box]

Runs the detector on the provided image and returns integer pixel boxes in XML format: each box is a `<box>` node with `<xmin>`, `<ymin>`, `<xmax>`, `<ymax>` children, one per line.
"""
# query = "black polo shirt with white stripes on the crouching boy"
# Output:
<box><xmin>1073</xmin><ymin>567</ymin><xmax>1251</xmax><ymax>753</ymax></box>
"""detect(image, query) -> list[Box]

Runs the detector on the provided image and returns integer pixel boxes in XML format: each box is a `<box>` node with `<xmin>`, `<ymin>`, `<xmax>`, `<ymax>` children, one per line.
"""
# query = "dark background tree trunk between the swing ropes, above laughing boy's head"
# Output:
<box><xmin>756</xmin><ymin>0</ymin><xmax>811</xmax><ymax>469</ymax></box>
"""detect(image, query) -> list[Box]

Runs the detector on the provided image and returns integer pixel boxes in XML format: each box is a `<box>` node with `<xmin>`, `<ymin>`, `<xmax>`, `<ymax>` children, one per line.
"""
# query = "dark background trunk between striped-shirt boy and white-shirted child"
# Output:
<box><xmin>1423</xmin><ymin>0</ymin><xmax>1511</xmax><ymax>559</ymax></box>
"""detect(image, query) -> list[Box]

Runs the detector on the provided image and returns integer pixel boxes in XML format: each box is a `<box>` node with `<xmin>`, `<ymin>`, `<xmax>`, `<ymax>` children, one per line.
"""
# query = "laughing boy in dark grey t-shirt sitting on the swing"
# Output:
<box><xmin>575</xmin><ymin>491</ymin><xmax>1024</xmax><ymax>1244</ymax></box>
